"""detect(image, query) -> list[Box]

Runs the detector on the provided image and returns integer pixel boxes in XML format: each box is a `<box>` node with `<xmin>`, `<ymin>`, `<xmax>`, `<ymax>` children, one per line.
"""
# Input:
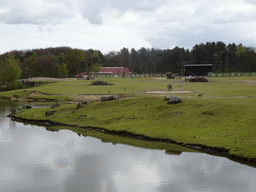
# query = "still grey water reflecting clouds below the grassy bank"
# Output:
<box><xmin>0</xmin><ymin>101</ymin><xmax>256</xmax><ymax>192</ymax></box>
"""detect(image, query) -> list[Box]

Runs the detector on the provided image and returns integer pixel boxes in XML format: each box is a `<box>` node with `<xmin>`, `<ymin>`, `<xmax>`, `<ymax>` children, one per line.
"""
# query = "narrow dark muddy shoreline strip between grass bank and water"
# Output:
<box><xmin>8</xmin><ymin>114</ymin><xmax>256</xmax><ymax>167</ymax></box>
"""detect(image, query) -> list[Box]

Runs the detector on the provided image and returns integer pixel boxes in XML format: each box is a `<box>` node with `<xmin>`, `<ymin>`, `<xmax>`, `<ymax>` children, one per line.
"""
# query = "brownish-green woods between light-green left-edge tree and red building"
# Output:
<box><xmin>0</xmin><ymin>47</ymin><xmax>104</xmax><ymax>78</ymax></box>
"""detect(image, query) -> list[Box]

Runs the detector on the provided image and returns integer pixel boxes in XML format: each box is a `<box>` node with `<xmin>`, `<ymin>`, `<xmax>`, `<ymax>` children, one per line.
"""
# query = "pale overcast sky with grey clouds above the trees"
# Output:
<box><xmin>0</xmin><ymin>0</ymin><xmax>256</xmax><ymax>54</ymax></box>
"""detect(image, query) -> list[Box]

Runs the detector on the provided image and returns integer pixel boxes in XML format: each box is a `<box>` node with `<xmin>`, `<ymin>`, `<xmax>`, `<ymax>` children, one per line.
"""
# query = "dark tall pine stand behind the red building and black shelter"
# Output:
<box><xmin>104</xmin><ymin>41</ymin><xmax>256</xmax><ymax>75</ymax></box>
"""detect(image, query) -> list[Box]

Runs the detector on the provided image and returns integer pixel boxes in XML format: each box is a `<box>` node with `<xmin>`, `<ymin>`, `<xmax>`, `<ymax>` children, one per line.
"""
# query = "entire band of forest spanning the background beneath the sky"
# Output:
<box><xmin>0</xmin><ymin>41</ymin><xmax>256</xmax><ymax>90</ymax></box>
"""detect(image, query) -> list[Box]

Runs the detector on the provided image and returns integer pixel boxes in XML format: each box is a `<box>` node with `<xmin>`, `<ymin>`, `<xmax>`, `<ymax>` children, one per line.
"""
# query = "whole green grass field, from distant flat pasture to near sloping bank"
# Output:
<box><xmin>0</xmin><ymin>77</ymin><xmax>256</xmax><ymax>161</ymax></box>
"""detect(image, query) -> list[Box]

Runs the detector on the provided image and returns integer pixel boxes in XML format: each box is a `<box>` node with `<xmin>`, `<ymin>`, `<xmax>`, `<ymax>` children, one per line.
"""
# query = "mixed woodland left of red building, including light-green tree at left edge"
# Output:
<box><xmin>0</xmin><ymin>47</ymin><xmax>104</xmax><ymax>90</ymax></box>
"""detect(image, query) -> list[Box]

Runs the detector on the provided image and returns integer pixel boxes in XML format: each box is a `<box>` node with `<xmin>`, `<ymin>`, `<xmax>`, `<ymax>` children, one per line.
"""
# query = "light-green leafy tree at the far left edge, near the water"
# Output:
<box><xmin>0</xmin><ymin>53</ymin><xmax>21</xmax><ymax>90</ymax></box>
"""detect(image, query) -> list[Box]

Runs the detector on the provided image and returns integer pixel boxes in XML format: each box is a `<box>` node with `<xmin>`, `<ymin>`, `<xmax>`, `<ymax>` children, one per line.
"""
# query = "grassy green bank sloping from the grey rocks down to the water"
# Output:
<box><xmin>9</xmin><ymin>97</ymin><xmax>256</xmax><ymax>161</ymax></box>
